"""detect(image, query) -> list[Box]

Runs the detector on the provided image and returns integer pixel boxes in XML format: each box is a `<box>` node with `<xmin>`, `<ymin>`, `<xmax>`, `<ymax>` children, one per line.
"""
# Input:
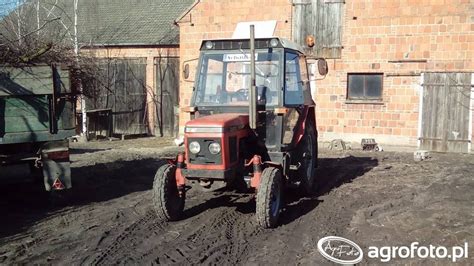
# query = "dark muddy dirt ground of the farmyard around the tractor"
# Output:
<box><xmin>0</xmin><ymin>138</ymin><xmax>474</xmax><ymax>265</ymax></box>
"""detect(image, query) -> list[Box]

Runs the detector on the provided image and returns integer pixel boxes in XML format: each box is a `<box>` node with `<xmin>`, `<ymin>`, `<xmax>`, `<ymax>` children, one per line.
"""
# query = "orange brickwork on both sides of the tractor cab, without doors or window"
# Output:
<box><xmin>179</xmin><ymin>0</ymin><xmax>474</xmax><ymax>148</ymax></box>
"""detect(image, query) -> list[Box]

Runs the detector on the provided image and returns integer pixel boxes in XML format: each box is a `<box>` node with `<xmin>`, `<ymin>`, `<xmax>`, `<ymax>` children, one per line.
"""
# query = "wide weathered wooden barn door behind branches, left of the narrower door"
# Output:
<box><xmin>86</xmin><ymin>58</ymin><xmax>148</xmax><ymax>135</ymax></box>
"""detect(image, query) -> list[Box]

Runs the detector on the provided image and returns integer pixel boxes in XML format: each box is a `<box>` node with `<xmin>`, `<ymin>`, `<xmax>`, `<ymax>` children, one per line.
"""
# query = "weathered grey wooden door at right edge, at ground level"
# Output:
<box><xmin>420</xmin><ymin>73</ymin><xmax>472</xmax><ymax>152</ymax></box>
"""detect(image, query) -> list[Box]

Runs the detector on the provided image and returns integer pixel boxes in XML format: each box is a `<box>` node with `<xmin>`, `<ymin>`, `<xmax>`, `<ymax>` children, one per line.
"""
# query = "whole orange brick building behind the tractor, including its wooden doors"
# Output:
<box><xmin>177</xmin><ymin>0</ymin><xmax>474</xmax><ymax>152</ymax></box>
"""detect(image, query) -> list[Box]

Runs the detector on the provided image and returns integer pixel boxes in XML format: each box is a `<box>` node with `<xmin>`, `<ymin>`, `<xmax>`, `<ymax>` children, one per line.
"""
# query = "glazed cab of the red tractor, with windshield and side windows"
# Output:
<box><xmin>186</xmin><ymin>38</ymin><xmax>315</xmax><ymax>154</ymax></box>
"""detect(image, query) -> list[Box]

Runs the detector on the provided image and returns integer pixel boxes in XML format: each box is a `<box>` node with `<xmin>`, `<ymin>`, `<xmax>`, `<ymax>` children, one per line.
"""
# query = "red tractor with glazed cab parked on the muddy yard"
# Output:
<box><xmin>153</xmin><ymin>28</ymin><xmax>325</xmax><ymax>228</ymax></box>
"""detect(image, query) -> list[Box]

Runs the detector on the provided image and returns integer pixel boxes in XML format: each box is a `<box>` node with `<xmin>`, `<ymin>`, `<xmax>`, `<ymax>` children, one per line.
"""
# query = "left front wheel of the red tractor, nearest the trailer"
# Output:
<box><xmin>153</xmin><ymin>164</ymin><xmax>185</xmax><ymax>221</ymax></box>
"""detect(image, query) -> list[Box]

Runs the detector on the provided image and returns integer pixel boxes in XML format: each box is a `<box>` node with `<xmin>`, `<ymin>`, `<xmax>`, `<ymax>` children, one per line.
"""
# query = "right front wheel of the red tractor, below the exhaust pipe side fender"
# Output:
<box><xmin>256</xmin><ymin>167</ymin><xmax>283</xmax><ymax>228</ymax></box>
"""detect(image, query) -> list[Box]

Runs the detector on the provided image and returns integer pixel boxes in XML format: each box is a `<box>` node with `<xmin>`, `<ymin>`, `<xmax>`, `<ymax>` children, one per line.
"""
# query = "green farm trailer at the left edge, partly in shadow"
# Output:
<box><xmin>0</xmin><ymin>65</ymin><xmax>75</xmax><ymax>191</ymax></box>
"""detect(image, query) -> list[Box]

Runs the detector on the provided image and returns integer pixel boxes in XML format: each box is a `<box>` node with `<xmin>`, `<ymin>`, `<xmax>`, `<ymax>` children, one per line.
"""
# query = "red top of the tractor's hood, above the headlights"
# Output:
<box><xmin>185</xmin><ymin>113</ymin><xmax>249</xmax><ymax>133</ymax></box>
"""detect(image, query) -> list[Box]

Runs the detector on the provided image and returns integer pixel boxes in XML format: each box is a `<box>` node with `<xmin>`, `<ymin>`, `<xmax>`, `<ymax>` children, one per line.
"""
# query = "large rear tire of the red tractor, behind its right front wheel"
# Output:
<box><xmin>299</xmin><ymin>122</ymin><xmax>318</xmax><ymax>196</ymax></box>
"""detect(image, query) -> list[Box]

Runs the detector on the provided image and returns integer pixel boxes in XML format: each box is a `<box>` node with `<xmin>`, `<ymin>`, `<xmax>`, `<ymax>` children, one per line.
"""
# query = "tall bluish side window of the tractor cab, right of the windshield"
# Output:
<box><xmin>285</xmin><ymin>52</ymin><xmax>304</xmax><ymax>105</ymax></box>
